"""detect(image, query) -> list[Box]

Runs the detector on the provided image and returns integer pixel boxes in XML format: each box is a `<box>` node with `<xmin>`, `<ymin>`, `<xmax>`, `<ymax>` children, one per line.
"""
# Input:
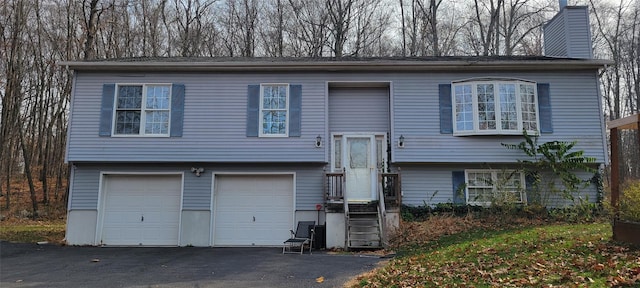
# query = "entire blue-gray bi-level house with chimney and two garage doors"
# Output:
<box><xmin>63</xmin><ymin>7</ymin><xmax>607</xmax><ymax>248</ymax></box>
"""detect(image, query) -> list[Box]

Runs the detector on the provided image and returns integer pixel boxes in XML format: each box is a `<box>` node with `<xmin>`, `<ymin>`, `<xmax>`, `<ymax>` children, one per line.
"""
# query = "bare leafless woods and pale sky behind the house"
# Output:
<box><xmin>0</xmin><ymin>0</ymin><xmax>640</xmax><ymax>217</ymax></box>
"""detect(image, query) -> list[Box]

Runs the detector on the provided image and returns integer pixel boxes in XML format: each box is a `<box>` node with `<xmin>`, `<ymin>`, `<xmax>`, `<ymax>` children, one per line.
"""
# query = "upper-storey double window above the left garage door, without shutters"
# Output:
<box><xmin>113</xmin><ymin>84</ymin><xmax>171</xmax><ymax>136</ymax></box>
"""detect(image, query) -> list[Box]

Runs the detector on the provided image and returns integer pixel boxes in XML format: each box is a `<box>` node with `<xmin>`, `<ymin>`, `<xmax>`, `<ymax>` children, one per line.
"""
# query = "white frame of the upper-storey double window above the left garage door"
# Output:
<box><xmin>111</xmin><ymin>83</ymin><xmax>173</xmax><ymax>137</ymax></box>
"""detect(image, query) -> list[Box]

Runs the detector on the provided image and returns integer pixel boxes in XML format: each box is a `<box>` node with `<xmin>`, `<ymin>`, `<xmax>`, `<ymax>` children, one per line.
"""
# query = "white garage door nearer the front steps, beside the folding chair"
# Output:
<box><xmin>213</xmin><ymin>175</ymin><xmax>293</xmax><ymax>246</ymax></box>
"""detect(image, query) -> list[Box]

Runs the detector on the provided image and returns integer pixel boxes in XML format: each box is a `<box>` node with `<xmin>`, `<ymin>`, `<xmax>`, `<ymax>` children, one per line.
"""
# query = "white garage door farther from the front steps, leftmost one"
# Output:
<box><xmin>101</xmin><ymin>175</ymin><xmax>182</xmax><ymax>246</ymax></box>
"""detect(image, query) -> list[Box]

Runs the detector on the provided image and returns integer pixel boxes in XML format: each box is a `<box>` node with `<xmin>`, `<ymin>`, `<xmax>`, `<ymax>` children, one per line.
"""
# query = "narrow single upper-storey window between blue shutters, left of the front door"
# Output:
<box><xmin>259</xmin><ymin>84</ymin><xmax>289</xmax><ymax>137</ymax></box>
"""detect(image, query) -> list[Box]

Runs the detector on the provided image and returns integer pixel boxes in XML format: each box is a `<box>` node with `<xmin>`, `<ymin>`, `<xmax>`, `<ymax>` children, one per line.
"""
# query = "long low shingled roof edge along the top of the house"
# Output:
<box><xmin>60</xmin><ymin>56</ymin><xmax>612</xmax><ymax>72</ymax></box>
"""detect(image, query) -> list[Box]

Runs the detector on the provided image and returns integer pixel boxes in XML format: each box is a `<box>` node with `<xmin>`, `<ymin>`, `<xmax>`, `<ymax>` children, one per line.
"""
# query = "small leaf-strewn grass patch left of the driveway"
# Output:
<box><xmin>0</xmin><ymin>221</ymin><xmax>65</xmax><ymax>244</ymax></box>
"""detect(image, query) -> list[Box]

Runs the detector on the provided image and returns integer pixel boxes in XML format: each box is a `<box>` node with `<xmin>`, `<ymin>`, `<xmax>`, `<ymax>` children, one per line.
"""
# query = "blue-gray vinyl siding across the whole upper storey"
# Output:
<box><xmin>68</xmin><ymin>70</ymin><xmax>605</xmax><ymax>164</ymax></box>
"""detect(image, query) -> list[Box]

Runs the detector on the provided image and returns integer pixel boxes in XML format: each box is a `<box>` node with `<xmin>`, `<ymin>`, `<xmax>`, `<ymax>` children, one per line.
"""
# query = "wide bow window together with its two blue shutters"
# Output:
<box><xmin>439</xmin><ymin>78</ymin><xmax>553</xmax><ymax>136</ymax></box>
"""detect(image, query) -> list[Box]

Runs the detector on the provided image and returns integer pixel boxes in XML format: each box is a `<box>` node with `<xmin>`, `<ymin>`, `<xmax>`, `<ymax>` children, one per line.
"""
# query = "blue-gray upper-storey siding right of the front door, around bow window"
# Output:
<box><xmin>392</xmin><ymin>71</ymin><xmax>605</xmax><ymax>163</ymax></box>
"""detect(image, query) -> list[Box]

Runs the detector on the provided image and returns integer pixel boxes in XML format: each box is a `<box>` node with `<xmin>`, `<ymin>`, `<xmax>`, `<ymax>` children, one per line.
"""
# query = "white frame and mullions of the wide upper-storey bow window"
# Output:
<box><xmin>451</xmin><ymin>79</ymin><xmax>540</xmax><ymax>136</ymax></box>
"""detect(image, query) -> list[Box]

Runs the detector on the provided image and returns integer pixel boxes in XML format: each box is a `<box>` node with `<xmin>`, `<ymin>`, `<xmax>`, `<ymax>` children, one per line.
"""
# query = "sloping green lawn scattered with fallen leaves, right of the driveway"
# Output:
<box><xmin>352</xmin><ymin>223</ymin><xmax>640</xmax><ymax>287</ymax></box>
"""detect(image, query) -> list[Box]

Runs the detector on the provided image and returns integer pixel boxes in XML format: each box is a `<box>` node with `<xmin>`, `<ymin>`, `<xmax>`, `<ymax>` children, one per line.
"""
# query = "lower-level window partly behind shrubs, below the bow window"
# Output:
<box><xmin>465</xmin><ymin>170</ymin><xmax>526</xmax><ymax>206</ymax></box>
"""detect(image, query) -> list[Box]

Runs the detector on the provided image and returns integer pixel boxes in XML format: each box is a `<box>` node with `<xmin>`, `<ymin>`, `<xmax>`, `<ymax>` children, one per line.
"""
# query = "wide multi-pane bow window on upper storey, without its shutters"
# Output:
<box><xmin>452</xmin><ymin>80</ymin><xmax>538</xmax><ymax>135</ymax></box>
